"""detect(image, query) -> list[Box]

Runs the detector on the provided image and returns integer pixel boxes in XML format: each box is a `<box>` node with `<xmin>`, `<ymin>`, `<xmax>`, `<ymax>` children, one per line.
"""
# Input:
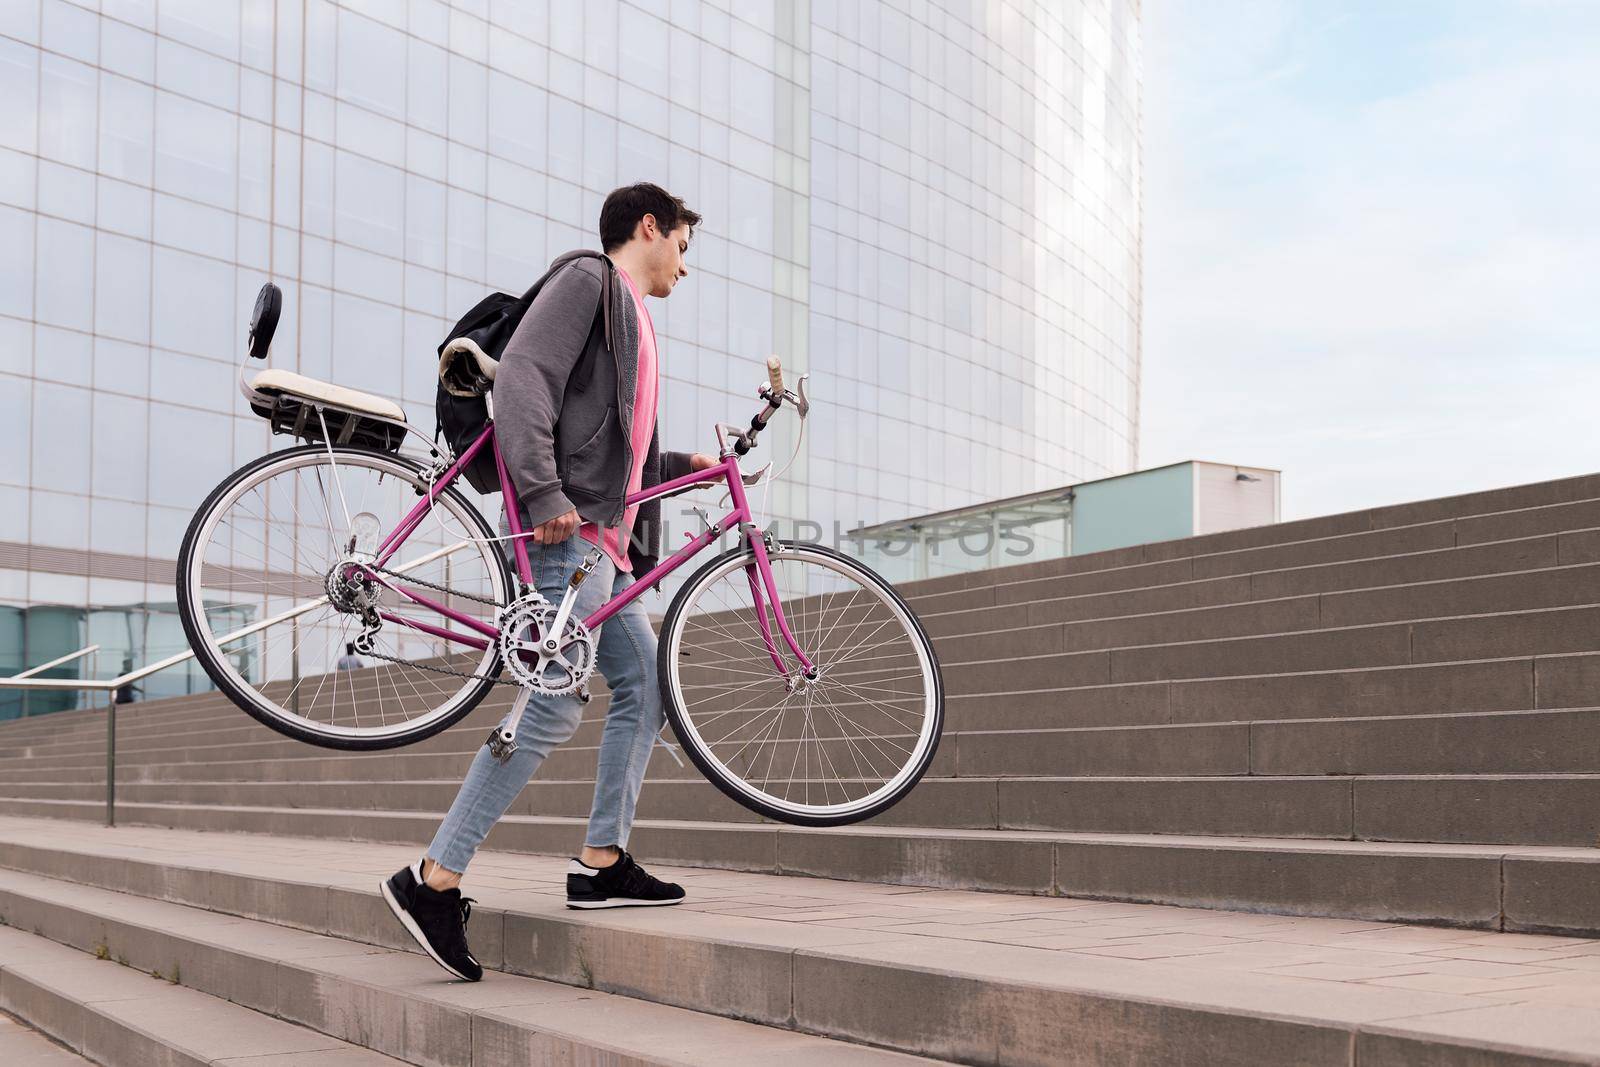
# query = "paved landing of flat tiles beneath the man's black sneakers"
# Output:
<box><xmin>0</xmin><ymin>817</ymin><xmax>1600</xmax><ymax>1011</ymax></box>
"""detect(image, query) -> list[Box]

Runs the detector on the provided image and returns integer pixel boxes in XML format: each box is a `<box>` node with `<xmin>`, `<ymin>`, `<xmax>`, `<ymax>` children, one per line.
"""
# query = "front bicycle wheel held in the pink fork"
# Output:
<box><xmin>659</xmin><ymin>544</ymin><xmax>944</xmax><ymax>825</ymax></box>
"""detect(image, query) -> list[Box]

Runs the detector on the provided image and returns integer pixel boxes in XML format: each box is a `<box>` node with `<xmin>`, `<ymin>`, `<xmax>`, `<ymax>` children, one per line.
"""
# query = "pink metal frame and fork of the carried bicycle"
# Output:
<box><xmin>358</xmin><ymin>422</ymin><xmax>814</xmax><ymax>675</ymax></box>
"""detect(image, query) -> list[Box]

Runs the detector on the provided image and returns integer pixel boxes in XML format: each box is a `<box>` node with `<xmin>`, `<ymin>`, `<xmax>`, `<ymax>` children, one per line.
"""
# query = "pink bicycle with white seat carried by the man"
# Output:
<box><xmin>178</xmin><ymin>283</ymin><xmax>944</xmax><ymax>825</ymax></box>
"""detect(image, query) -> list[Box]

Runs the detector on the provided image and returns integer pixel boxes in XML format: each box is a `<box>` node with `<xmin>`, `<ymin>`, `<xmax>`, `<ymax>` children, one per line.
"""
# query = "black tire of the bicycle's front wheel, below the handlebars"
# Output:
<box><xmin>656</xmin><ymin>544</ymin><xmax>944</xmax><ymax>827</ymax></box>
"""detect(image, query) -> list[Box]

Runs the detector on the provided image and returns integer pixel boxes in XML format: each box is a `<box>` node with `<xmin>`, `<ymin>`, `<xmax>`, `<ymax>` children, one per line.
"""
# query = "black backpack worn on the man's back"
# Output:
<box><xmin>434</xmin><ymin>250</ymin><xmax>616</xmax><ymax>496</ymax></box>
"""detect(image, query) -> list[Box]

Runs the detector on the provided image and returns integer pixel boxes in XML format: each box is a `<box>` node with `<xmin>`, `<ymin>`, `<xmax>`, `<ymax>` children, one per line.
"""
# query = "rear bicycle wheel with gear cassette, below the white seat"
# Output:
<box><xmin>178</xmin><ymin>445</ymin><xmax>514</xmax><ymax>750</ymax></box>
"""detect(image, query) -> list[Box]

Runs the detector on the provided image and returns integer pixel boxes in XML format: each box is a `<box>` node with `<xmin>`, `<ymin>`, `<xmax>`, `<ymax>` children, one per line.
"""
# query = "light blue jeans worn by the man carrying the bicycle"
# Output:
<box><xmin>427</xmin><ymin>512</ymin><xmax>664</xmax><ymax>873</ymax></box>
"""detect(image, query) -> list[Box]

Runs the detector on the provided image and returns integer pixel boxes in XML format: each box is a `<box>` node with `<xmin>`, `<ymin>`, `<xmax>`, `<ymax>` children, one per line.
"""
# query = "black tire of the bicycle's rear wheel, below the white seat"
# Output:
<box><xmin>178</xmin><ymin>445</ymin><xmax>517</xmax><ymax>752</ymax></box>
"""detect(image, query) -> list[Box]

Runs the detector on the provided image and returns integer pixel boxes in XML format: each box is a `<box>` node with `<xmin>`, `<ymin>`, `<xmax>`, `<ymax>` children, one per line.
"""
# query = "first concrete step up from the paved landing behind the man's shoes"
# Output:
<box><xmin>0</xmin><ymin>800</ymin><xmax>1600</xmax><ymax>936</ymax></box>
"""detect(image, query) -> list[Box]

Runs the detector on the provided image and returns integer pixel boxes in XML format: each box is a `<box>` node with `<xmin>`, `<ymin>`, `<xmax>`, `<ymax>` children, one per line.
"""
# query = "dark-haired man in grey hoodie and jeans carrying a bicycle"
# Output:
<box><xmin>382</xmin><ymin>182</ymin><xmax>715</xmax><ymax>982</ymax></box>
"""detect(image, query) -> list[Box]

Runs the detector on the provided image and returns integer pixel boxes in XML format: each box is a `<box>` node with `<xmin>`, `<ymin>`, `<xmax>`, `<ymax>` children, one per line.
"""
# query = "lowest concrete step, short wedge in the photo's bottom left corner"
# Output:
<box><xmin>0</xmin><ymin>925</ymin><xmax>405</xmax><ymax>1067</ymax></box>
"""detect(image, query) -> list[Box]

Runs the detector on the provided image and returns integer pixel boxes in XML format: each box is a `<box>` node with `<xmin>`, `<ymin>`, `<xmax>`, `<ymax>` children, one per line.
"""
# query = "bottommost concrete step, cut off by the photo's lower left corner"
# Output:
<box><xmin>0</xmin><ymin>927</ymin><xmax>406</xmax><ymax>1067</ymax></box>
